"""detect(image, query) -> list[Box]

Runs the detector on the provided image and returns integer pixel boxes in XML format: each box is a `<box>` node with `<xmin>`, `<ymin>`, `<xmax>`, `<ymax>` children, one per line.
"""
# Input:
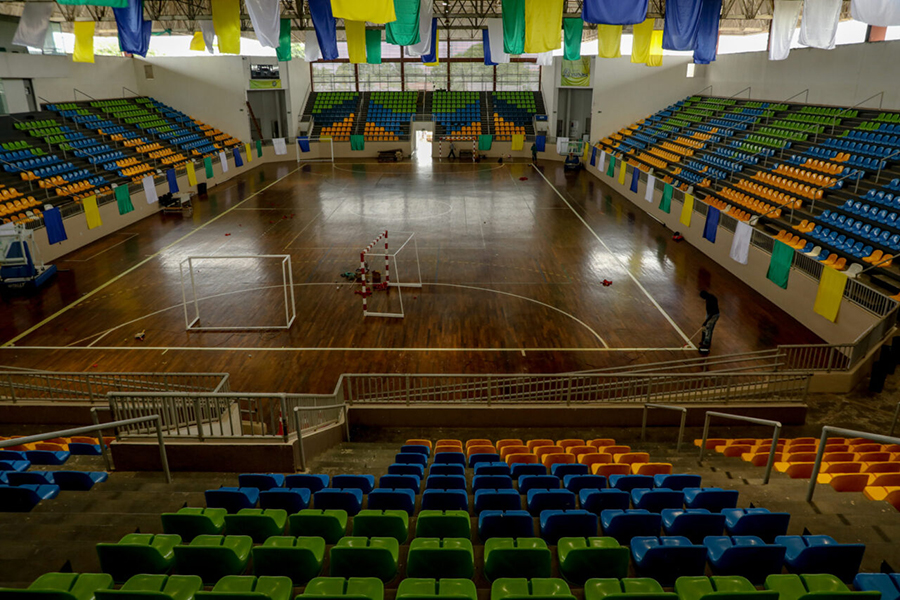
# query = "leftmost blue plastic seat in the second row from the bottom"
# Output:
<box><xmin>631</xmin><ymin>536</ymin><xmax>706</xmax><ymax>586</ymax></box>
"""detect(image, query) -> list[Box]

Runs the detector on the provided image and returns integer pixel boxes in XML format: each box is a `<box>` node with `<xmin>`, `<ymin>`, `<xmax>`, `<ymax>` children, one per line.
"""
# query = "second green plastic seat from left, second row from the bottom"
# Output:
<box><xmin>175</xmin><ymin>535</ymin><xmax>253</xmax><ymax>583</ymax></box>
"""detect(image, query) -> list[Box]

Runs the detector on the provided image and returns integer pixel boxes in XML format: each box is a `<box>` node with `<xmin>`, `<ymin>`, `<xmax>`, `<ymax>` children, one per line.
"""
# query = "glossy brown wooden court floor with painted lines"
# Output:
<box><xmin>0</xmin><ymin>161</ymin><xmax>821</xmax><ymax>393</ymax></box>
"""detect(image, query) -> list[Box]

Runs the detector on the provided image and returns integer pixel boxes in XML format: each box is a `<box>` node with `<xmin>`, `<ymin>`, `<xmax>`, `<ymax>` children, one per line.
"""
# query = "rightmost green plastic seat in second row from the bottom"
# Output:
<box><xmin>556</xmin><ymin>537</ymin><xmax>631</xmax><ymax>584</ymax></box>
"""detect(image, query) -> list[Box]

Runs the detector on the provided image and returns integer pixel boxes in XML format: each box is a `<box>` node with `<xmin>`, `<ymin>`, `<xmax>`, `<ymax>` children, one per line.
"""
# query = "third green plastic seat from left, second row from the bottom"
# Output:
<box><xmin>252</xmin><ymin>536</ymin><xmax>326</xmax><ymax>585</ymax></box>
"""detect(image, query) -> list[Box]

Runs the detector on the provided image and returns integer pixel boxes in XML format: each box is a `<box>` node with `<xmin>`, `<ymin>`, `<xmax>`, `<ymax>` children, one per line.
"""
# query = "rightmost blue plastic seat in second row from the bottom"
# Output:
<box><xmin>775</xmin><ymin>535</ymin><xmax>866</xmax><ymax>583</ymax></box>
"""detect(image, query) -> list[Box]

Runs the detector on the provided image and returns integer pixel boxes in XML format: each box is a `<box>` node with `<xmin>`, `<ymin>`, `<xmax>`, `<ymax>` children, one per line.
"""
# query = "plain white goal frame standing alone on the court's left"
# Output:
<box><xmin>179</xmin><ymin>254</ymin><xmax>297</xmax><ymax>331</ymax></box>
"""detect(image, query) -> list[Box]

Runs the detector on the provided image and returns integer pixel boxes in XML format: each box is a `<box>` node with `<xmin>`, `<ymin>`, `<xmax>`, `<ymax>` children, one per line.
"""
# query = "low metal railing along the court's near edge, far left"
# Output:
<box><xmin>0</xmin><ymin>370</ymin><xmax>230</xmax><ymax>404</ymax></box>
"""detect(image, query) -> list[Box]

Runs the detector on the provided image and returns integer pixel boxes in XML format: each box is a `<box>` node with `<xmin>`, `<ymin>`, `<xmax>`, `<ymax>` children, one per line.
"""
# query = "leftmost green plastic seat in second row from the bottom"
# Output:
<box><xmin>97</xmin><ymin>533</ymin><xmax>181</xmax><ymax>582</ymax></box>
